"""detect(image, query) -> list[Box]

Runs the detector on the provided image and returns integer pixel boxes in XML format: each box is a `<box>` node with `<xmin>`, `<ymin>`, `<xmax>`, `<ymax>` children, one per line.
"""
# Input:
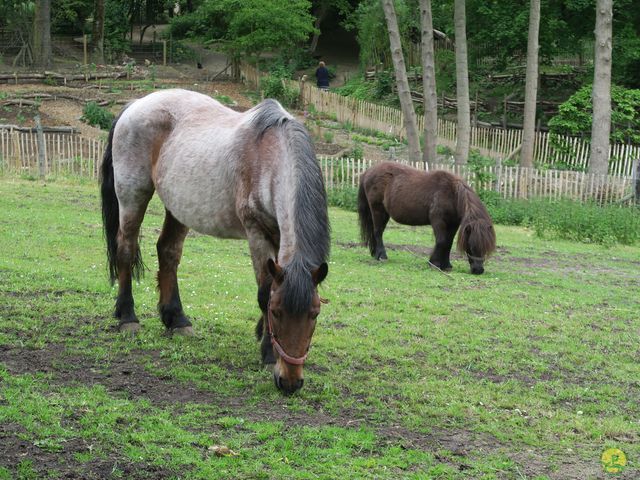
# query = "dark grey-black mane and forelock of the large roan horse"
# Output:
<box><xmin>251</xmin><ymin>99</ymin><xmax>330</xmax><ymax>314</ymax></box>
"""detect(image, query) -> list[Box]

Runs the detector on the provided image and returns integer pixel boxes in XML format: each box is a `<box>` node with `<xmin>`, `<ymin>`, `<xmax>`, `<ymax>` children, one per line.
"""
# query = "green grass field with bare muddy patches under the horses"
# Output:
<box><xmin>0</xmin><ymin>178</ymin><xmax>640</xmax><ymax>480</ymax></box>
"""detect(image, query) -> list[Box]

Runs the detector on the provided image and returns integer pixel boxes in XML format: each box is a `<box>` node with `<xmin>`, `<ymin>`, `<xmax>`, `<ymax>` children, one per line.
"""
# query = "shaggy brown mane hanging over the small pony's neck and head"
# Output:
<box><xmin>457</xmin><ymin>182</ymin><xmax>496</xmax><ymax>258</ymax></box>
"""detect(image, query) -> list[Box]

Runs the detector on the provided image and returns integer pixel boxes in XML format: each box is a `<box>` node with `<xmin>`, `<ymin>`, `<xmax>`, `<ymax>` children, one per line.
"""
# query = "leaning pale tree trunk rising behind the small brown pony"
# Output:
<box><xmin>382</xmin><ymin>0</ymin><xmax>422</xmax><ymax>162</ymax></box>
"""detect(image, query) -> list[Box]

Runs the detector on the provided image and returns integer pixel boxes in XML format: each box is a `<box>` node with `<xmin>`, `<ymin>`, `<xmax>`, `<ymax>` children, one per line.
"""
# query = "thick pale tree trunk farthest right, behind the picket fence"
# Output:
<box><xmin>589</xmin><ymin>0</ymin><xmax>613</xmax><ymax>175</ymax></box>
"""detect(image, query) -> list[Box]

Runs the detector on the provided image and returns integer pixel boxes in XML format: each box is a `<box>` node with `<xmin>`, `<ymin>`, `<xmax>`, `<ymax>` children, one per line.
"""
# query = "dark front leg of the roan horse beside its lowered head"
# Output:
<box><xmin>245</xmin><ymin>229</ymin><xmax>278</xmax><ymax>365</ymax></box>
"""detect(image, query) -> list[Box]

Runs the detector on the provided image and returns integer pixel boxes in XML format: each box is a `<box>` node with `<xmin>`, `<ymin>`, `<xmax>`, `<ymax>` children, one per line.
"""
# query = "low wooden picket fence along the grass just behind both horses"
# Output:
<box><xmin>0</xmin><ymin>130</ymin><xmax>634</xmax><ymax>203</ymax></box>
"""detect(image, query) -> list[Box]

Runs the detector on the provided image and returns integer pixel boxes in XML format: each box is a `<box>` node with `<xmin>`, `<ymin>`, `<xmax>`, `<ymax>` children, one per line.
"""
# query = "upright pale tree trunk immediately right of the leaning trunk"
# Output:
<box><xmin>420</xmin><ymin>0</ymin><xmax>438</xmax><ymax>165</ymax></box>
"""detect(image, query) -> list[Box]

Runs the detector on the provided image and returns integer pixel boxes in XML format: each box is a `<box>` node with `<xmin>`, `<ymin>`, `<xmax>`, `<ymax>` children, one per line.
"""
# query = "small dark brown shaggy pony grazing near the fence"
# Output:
<box><xmin>358</xmin><ymin>162</ymin><xmax>496</xmax><ymax>274</ymax></box>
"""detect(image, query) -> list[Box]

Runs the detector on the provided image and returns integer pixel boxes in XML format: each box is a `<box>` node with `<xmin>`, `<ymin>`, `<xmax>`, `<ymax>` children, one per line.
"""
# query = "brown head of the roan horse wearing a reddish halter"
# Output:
<box><xmin>266</xmin><ymin>259</ymin><xmax>328</xmax><ymax>394</ymax></box>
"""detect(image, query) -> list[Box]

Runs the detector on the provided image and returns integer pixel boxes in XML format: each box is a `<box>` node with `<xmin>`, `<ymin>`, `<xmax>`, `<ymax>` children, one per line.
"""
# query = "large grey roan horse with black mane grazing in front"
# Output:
<box><xmin>101</xmin><ymin>90</ymin><xmax>329</xmax><ymax>393</ymax></box>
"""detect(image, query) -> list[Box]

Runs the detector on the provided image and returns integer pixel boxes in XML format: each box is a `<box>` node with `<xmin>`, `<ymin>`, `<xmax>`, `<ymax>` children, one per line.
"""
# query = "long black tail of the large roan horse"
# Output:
<box><xmin>100</xmin><ymin>105</ymin><xmax>144</xmax><ymax>285</ymax></box>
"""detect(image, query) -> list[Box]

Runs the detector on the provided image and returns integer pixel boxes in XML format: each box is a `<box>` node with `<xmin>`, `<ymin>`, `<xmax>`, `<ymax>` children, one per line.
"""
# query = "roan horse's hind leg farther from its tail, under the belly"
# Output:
<box><xmin>156</xmin><ymin>210</ymin><xmax>193</xmax><ymax>335</ymax></box>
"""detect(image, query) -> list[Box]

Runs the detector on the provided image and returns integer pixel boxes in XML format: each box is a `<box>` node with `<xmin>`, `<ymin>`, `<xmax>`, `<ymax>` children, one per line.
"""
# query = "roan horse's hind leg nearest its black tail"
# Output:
<box><xmin>114</xmin><ymin>201</ymin><xmax>151</xmax><ymax>332</ymax></box>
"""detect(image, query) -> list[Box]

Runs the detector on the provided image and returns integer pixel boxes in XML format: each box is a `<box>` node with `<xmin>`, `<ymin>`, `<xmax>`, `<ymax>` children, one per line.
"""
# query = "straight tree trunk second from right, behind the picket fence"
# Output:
<box><xmin>520</xmin><ymin>0</ymin><xmax>540</xmax><ymax>168</ymax></box>
